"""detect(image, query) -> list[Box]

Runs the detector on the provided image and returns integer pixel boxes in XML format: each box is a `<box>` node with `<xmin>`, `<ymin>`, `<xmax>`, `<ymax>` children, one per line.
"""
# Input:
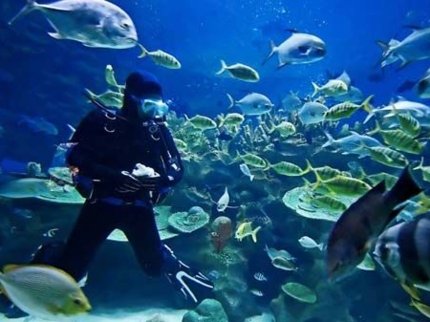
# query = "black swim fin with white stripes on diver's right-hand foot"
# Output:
<box><xmin>163</xmin><ymin>245</ymin><xmax>214</xmax><ymax>303</ymax></box>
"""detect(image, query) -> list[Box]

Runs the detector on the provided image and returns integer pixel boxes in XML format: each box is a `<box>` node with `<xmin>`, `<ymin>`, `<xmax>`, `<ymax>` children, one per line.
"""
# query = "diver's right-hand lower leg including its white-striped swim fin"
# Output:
<box><xmin>121</xmin><ymin>207</ymin><xmax>213</xmax><ymax>303</ymax></box>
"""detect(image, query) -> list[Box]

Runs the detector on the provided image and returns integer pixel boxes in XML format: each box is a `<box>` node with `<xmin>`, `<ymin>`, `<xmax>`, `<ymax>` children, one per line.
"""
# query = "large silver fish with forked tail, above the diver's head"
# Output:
<box><xmin>9</xmin><ymin>0</ymin><xmax>138</xmax><ymax>49</ymax></box>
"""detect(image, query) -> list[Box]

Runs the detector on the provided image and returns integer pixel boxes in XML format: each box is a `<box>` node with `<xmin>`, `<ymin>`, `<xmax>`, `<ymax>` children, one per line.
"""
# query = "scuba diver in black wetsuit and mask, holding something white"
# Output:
<box><xmin>1</xmin><ymin>71</ymin><xmax>213</xmax><ymax>316</ymax></box>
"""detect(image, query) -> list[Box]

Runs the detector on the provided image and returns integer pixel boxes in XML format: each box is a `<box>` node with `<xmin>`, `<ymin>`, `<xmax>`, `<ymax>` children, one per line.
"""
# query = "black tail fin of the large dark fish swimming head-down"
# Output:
<box><xmin>386</xmin><ymin>166</ymin><xmax>423</xmax><ymax>207</ymax></box>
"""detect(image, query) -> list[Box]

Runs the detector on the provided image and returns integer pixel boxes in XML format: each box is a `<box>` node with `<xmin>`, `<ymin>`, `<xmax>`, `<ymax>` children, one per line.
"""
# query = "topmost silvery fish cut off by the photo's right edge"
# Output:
<box><xmin>378</xmin><ymin>27</ymin><xmax>430</xmax><ymax>68</ymax></box>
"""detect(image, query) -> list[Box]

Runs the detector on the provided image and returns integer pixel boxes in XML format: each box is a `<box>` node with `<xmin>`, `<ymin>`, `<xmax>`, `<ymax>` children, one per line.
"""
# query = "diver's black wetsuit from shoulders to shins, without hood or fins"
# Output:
<box><xmin>53</xmin><ymin>109</ymin><xmax>183</xmax><ymax>280</ymax></box>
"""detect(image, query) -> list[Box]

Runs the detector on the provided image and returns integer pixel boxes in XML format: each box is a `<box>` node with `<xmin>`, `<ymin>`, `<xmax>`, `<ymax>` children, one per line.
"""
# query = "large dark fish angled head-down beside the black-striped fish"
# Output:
<box><xmin>326</xmin><ymin>167</ymin><xmax>422</xmax><ymax>280</ymax></box>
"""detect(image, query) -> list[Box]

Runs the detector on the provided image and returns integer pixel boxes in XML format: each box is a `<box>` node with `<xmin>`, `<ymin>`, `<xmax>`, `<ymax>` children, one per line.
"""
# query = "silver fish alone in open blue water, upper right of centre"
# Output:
<box><xmin>263</xmin><ymin>32</ymin><xmax>326</xmax><ymax>69</ymax></box>
